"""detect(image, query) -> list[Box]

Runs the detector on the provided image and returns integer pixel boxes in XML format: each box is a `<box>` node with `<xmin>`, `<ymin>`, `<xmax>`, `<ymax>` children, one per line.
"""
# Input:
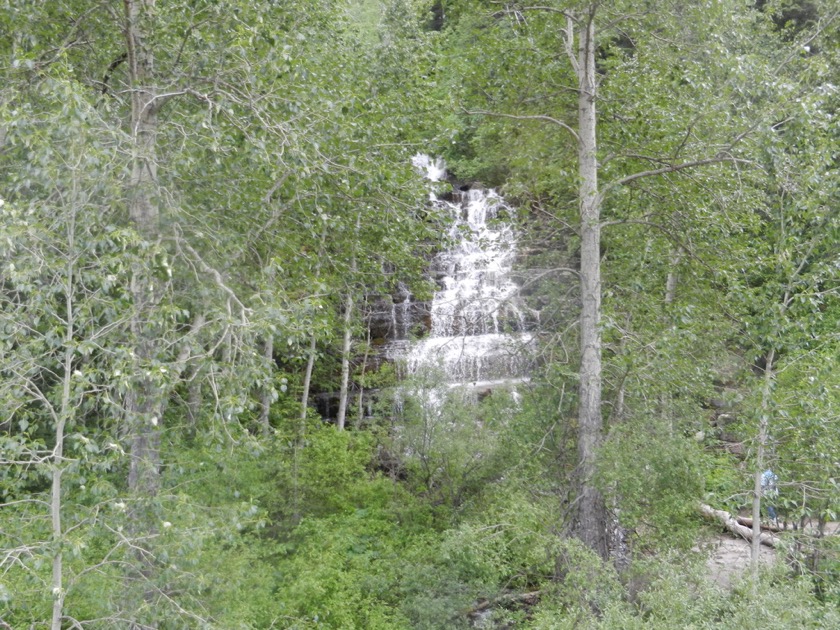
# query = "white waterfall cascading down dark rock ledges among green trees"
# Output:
<box><xmin>398</xmin><ymin>155</ymin><xmax>532</xmax><ymax>387</ymax></box>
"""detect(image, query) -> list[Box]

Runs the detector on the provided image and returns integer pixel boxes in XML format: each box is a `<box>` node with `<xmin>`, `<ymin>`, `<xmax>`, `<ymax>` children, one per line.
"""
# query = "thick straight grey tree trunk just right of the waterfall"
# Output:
<box><xmin>574</xmin><ymin>7</ymin><xmax>608</xmax><ymax>559</ymax></box>
